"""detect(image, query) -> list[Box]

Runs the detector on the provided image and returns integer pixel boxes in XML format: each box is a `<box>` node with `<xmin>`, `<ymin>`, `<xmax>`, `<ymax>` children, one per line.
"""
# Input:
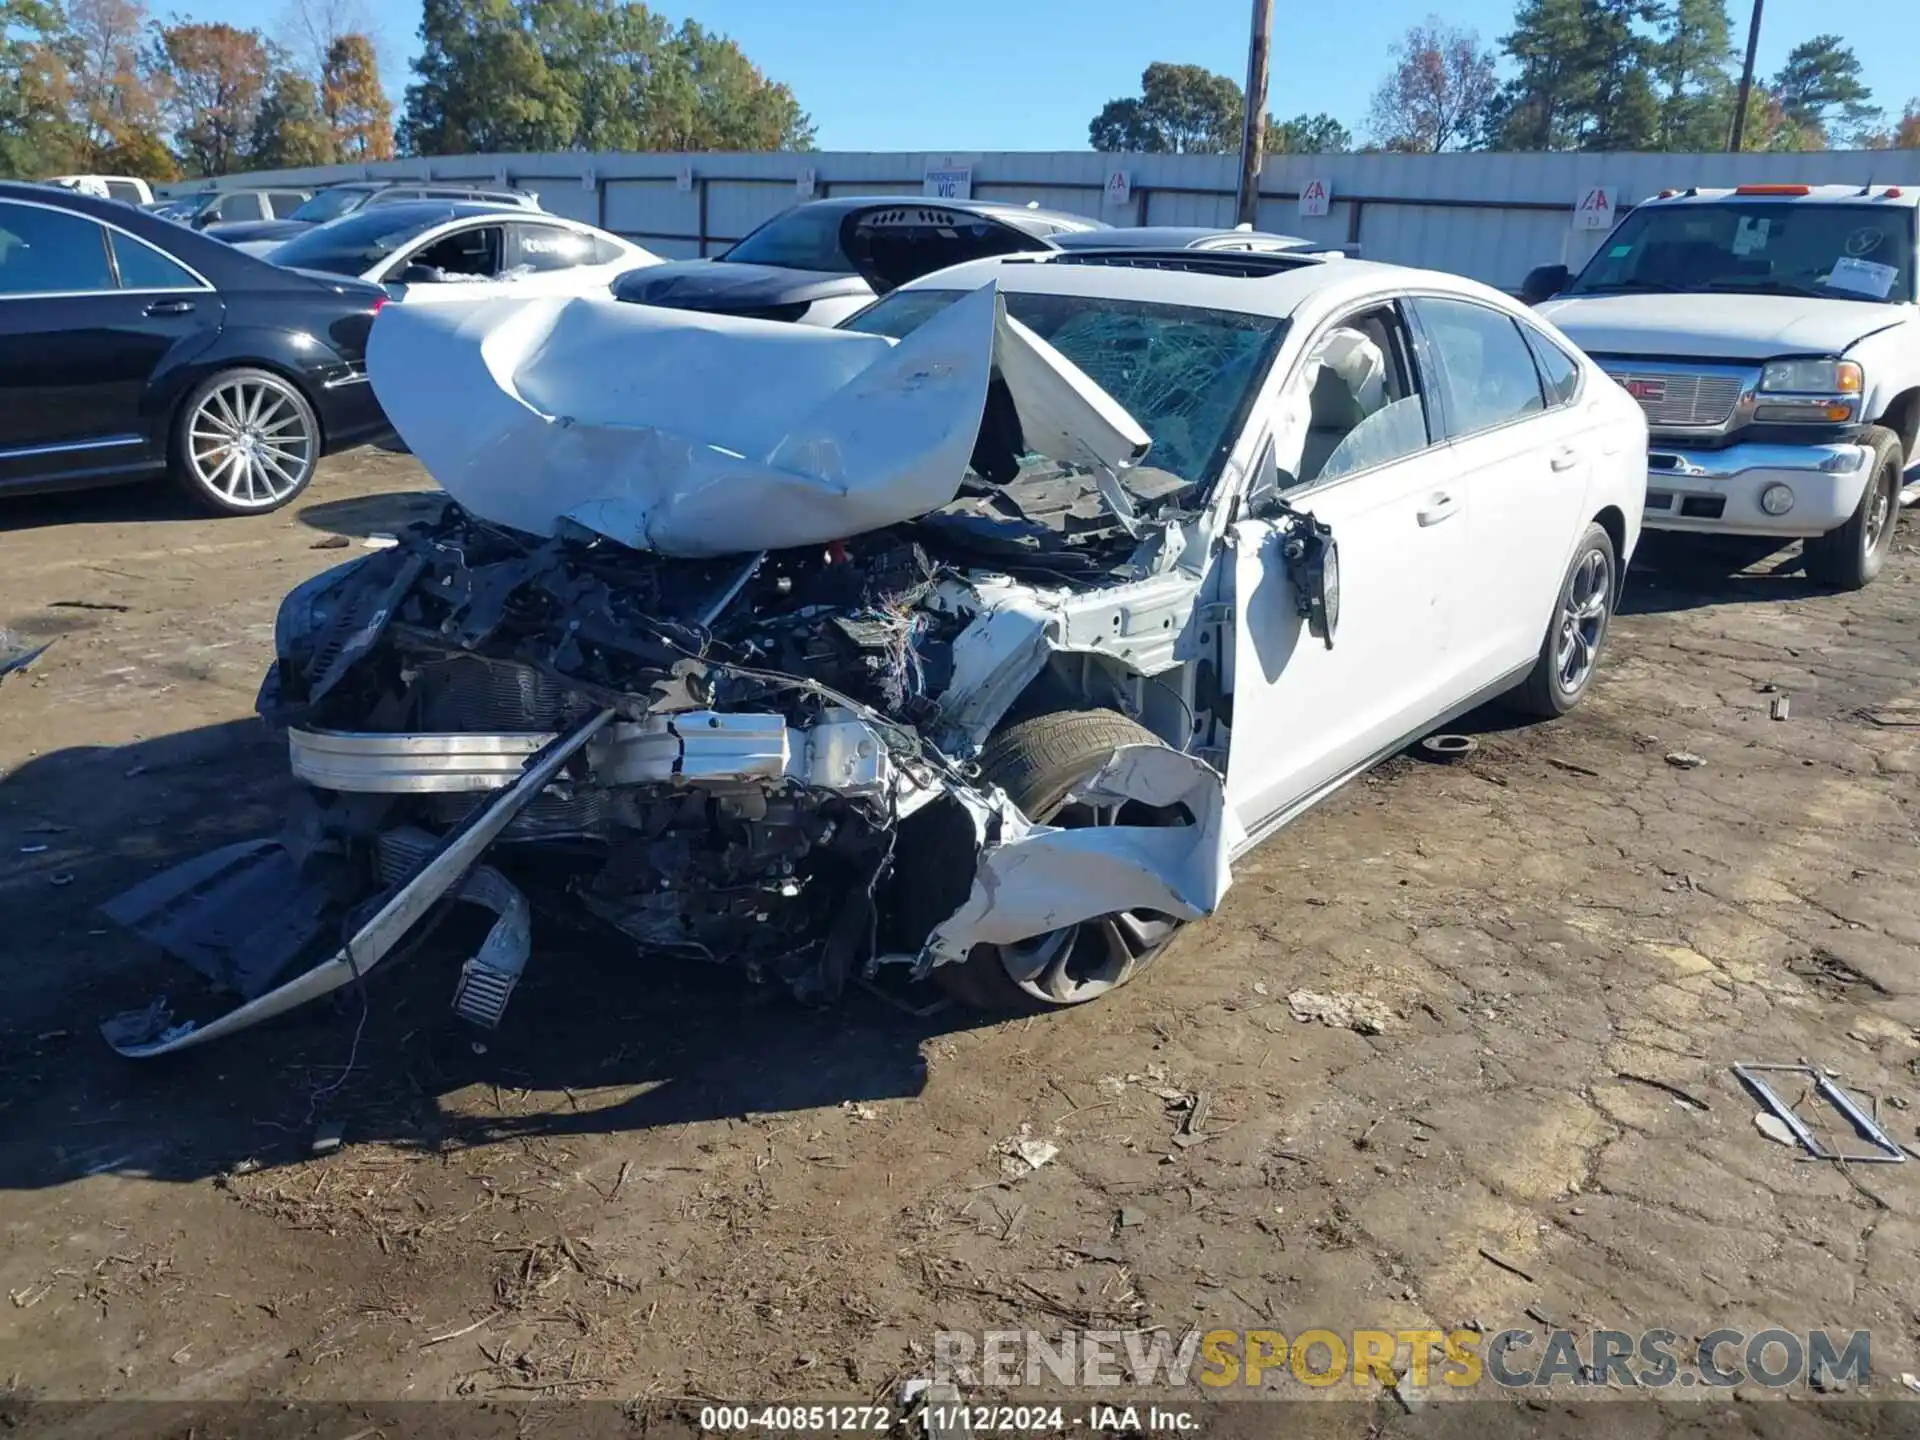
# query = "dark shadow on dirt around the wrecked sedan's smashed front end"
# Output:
<box><xmin>0</xmin><ymin>720</ymin><xmax>995</xmax><ymax>1190</ymax></box>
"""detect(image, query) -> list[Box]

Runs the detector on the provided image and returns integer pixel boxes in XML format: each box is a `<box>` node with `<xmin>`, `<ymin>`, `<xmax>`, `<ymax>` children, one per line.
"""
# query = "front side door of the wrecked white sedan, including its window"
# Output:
<box><xmin>1227</xmin><ymin>303</ymin><xmax>1469</xmax><ymax>839</ymax></box>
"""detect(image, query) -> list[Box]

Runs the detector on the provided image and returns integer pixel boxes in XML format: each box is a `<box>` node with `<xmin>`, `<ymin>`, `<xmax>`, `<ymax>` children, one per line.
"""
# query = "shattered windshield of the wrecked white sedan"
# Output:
<box><xmin>841</xmin><ymin>290</ymin><xmax>1286</xmax><ymax>484</ymax></box>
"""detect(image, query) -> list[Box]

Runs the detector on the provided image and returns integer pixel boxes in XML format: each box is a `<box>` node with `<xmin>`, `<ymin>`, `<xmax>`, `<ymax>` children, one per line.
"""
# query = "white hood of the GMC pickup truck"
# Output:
<box><xmin>1540</xmin><ymin>294</ymin><xmax>1907</xmax><ymax>361</ymax></box>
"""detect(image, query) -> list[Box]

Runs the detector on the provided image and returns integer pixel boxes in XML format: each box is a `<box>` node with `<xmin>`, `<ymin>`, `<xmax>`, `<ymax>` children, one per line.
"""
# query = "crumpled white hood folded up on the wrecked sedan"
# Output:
<box><xmin>369</xmin><ymin>286</ymin><xmax>1150</xmax><ymax>557</ymax></box>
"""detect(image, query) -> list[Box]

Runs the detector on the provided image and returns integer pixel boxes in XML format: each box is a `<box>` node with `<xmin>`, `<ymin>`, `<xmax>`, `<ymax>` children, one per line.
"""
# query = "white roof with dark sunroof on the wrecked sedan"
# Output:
<box><xmin>895</xmin><ymin>250</ymin><xmax>1519</xmax><ymax>319</ymax></box>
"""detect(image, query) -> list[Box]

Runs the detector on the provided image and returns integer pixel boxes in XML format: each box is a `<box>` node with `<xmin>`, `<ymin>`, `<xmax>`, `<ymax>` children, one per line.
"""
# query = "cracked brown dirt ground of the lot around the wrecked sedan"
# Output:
<box><xmin>0</xmin><ymin>453</ymin><xmax>1920</xmax><ymax>1432</ymax></box>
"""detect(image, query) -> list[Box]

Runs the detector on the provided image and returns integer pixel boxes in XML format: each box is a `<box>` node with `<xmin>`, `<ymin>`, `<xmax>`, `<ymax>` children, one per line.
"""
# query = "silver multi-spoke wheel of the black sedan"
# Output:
<box><xmin>171</xmin><ymin>369</ymin><xmax>321</xmax><ymax>515</ymax></box>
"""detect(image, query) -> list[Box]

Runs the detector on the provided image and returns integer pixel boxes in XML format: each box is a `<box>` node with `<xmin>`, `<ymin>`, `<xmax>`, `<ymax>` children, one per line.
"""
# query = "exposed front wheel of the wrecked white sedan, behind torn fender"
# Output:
<box><xmin>917</xmin><ymin>710</ymin><xmax>1185</xmax><ymax>1012</ymax></box>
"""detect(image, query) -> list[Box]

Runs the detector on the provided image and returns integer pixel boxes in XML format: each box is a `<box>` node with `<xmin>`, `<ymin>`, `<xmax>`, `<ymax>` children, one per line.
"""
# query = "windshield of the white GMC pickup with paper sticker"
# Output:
<box><xmin>1567</xmin><ymin>200</ymin><xmax>1914</xmax><ymax>303</ymax></box>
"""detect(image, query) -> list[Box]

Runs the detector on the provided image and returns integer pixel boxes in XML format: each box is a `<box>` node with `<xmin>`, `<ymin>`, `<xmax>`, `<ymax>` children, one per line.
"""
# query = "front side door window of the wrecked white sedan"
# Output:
<box><xmin>1275</xmin><ymin>305</ymin><xmax>1430</xmax><ymax>488</ymax></box>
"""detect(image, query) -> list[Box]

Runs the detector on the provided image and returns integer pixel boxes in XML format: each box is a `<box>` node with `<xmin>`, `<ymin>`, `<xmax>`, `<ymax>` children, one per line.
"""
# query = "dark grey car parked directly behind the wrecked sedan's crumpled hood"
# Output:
<box><xmin>612</xmin><ymin>196</ymin><xmax>1106</xmax><ymax>324</ymax></box>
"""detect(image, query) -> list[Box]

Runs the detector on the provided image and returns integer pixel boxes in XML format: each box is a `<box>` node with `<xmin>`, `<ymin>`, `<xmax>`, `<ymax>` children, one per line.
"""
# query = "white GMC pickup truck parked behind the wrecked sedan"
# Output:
<box><xmin>1521</xmin><ymin>184</ymin><xmax>1920</xmax><ymax>589</ymax></box>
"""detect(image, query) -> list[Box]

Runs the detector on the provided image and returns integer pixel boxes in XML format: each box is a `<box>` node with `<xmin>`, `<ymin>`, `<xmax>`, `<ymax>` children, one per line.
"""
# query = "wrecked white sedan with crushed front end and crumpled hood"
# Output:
<box><xmin>104</xmin><ymin>252</ymin><xmax>1645</xmax><ymax>1056</ymax></box>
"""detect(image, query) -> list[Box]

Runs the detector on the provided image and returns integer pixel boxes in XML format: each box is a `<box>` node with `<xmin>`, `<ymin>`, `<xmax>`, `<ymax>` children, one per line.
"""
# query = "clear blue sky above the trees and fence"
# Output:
<box><xmin>198</xmin><ymin>0</ymin><xmax>1920</xmax><ymax>150</ymax></box>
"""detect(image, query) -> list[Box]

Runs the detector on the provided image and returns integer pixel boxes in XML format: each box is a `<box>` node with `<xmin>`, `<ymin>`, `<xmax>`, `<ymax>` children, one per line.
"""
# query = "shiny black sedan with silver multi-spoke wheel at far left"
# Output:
<box><xmin>0</xmin><ymin>182</ymin><xmax>390</xmax><ymax>515</ymax></box>
